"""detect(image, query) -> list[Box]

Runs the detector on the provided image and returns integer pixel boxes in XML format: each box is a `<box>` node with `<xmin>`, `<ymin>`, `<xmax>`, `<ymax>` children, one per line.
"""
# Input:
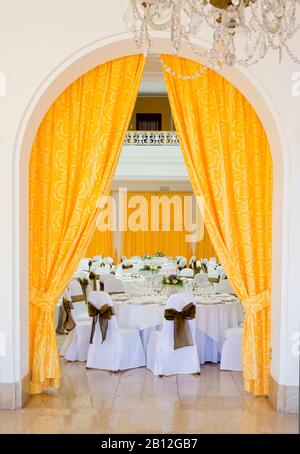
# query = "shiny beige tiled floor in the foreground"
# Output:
<box><xmin>0</xmin><ymin>360</ymin><xmax>297</xmax><ymax>434</ymax></box>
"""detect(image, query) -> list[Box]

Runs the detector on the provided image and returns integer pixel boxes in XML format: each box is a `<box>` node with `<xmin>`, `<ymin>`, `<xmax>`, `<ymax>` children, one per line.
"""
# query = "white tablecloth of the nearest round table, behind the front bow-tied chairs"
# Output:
<box><xmin>113</xmin><ymin>296</ymin><xmax>244</xmax><ymax>364</ymax></box>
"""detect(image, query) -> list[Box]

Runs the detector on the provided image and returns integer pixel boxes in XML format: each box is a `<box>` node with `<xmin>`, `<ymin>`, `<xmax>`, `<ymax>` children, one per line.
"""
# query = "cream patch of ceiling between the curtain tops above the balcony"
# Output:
<box><xmin>139</xmin><ymin>54</ymin><xmax>167</xmax><ymax>96</ymax></box>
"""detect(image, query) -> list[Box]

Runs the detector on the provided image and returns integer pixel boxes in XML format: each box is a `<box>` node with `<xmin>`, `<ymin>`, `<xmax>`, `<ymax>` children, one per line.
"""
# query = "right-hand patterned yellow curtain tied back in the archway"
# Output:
<box><xmin>162</xmin><ymin>55</ymin><xmax>272</xmax><ymax>395</ymax></box>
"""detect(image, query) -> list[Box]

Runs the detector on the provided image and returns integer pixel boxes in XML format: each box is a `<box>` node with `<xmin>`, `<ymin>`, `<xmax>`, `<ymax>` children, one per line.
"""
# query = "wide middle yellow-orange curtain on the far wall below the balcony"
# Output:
<box><xmin>122</xmin><ymin>192</ymin><xmax>192</xmax><ymax>258</ymax></box>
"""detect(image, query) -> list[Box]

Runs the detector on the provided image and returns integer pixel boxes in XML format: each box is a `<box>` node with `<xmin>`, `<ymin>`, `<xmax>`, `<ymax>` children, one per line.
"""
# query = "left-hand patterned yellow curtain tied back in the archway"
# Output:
<box><xmin>30</xmin><ymin>55</ymin><xmax>144</xmax><ymax>393</ymax></box>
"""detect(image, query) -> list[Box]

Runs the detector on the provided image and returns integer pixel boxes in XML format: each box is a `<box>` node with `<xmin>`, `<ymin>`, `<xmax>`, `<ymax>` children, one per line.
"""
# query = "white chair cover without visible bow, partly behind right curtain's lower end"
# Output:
<box><xmin>220</xmin><ymin>327</ymin><xmax>243</xmax><ymax>372</ymax></box>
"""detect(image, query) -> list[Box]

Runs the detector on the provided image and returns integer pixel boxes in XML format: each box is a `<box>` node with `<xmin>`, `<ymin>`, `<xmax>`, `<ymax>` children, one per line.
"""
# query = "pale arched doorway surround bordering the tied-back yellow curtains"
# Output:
<box><xmin>14</xmin><ymin>34</ymin><xmax>287</xmax><ymax>404</ymax></box>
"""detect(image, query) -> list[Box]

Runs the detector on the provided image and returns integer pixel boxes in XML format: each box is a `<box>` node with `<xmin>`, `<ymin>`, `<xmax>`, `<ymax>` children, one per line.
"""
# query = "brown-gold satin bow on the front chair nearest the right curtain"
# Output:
<box><xmin>165</xmin><ymin>303</ymin><xmax>196</xmax><ymax>350</ymax></box>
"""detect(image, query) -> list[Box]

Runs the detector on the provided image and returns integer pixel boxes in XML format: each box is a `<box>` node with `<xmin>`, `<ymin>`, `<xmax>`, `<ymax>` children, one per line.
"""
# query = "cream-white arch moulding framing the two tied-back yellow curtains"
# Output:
<box><xmin>13</xmin><ymin>34</ymin><xmax>289</xmax><ymax>404</ymax></box>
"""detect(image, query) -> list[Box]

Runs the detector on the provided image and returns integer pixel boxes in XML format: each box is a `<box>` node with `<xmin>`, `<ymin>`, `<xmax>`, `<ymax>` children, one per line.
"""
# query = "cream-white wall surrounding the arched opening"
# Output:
<box><xmin>0</xmin><ymin>0</ymin><xmax>300</xmax><ymax>385</ymax></box>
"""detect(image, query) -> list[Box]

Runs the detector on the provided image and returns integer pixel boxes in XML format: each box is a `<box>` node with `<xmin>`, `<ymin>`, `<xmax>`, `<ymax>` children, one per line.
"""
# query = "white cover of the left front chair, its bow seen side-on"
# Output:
<box><xmin>86</xmin><ymin>292</ymin><xmax>145</xmax><ymax>371</ymax></box>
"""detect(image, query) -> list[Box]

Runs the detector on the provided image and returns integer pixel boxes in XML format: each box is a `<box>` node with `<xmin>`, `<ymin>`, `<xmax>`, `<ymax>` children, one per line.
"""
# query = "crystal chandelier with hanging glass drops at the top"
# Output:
<box><xmin>124</xmin><ymin>0</ymin><xmax>300</xmax><ymax>70</ymax></box>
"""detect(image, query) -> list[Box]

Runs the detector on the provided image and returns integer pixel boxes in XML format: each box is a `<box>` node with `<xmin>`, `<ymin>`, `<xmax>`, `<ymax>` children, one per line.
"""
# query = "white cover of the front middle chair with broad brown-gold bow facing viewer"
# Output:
<box><xmin>147</xmin><ymin>293</ymin><xmax>200</xmax><ymax>375</ymax></box>
